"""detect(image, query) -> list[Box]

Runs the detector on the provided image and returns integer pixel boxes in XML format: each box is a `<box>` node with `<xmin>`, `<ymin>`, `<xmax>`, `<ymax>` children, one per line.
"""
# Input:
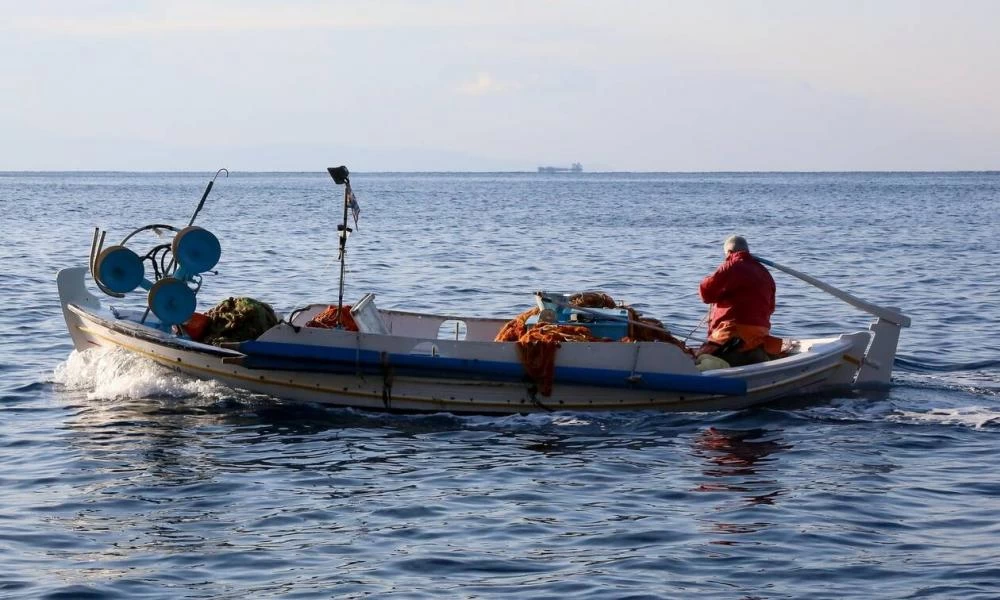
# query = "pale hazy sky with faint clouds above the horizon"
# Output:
<box><xmin>0</xmin><ymin>0</ymin><xmax>1000</xmax><ymax>171</ymax></box>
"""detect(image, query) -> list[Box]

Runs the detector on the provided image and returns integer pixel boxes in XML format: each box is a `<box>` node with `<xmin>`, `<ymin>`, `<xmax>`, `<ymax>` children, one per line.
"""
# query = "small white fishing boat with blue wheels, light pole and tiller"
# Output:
<box><xmin>57</xmin><ymin>167</ymin><xmax>910</xmax><ymax>414</ymax></box>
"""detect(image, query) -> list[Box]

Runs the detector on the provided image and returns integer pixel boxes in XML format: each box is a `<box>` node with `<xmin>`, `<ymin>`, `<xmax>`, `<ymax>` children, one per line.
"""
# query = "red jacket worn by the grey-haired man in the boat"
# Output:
<box><xmin>698</xmin><ymin>250</ymin><xmax>774</xmax><ymax>334</ymax></box>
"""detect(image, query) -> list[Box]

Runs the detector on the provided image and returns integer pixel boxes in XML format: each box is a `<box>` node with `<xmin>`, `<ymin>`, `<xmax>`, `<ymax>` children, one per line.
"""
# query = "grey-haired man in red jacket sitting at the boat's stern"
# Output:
<box><xmin>696</xmin><ymin>235</ymin><xmax>781</xmax><ymax>367</ymax></box>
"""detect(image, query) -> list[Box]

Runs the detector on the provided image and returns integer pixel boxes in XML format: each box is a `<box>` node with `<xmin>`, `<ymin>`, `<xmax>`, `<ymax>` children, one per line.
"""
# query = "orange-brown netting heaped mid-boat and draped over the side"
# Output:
<box><xmin>494</xmin><ymin>292</ymin><xmax>693</xmax><ymax>396</ymax></box>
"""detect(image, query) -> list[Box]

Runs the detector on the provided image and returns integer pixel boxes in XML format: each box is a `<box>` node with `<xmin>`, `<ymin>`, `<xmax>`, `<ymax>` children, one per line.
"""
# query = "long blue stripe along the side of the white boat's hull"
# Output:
<box><xmin>240</xmin><ymin>341</ymin><xmax>747</xmax><ymax>396</ymax></box>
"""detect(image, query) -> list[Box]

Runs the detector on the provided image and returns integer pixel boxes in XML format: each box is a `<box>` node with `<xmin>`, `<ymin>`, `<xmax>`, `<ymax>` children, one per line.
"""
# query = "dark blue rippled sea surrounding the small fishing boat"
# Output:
<box><xmin>0</xmin><ymin>171</ymin><xmax>1000</xmax><ymax>600</ymax></box>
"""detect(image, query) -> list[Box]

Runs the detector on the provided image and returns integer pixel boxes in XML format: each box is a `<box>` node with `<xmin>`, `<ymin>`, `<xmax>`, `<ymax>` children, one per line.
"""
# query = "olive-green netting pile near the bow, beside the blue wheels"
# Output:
<box><xmin>184</xmin><ymin>298</ymin><xmax>278</xmax><ymax>346</ymax></box>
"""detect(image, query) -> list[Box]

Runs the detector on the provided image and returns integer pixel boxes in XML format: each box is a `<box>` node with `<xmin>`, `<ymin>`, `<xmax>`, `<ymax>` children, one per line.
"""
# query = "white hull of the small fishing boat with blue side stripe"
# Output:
<box><xmin>58</xmin><ymin>268</ymin><xmax>895</xmax><ymax>414</ymax></box>
